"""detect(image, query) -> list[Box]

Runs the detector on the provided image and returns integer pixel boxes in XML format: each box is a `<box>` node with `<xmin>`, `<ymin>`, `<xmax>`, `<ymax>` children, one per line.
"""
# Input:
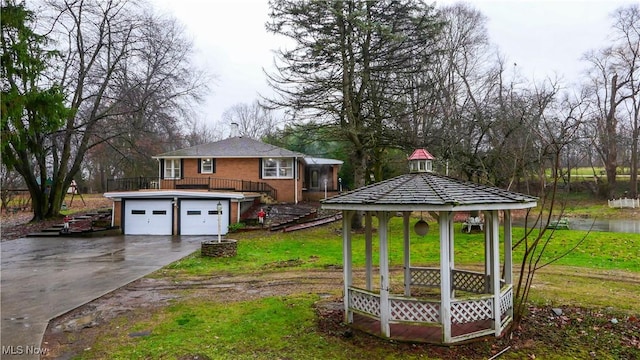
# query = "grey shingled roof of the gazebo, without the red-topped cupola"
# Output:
<box><xmin>323</xmin><ymin>173</ymin><xmax>537</xmax><ymax>211</ymax></box>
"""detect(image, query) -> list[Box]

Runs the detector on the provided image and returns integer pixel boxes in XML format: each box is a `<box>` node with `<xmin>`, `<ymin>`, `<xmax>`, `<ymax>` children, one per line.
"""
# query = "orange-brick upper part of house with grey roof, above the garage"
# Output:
<box><xmin>153</xmin><ymin>137</ymin><xmax>342</xmax><ymax>203</ymax></box>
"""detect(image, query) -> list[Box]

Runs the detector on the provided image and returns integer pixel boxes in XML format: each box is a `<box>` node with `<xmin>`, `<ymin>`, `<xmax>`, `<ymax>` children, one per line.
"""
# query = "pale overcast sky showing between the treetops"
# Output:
<box><xmin>152</xmin><ymin>0</ymin><xmax>633</xmax><ymax>129</ymax></box>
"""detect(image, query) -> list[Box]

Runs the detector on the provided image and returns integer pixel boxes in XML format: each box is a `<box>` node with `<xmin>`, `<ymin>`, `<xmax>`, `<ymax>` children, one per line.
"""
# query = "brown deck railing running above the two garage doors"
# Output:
<box><xmin>107</xmin><ymin>176</ymin><xmax>277</xmax><ymax>199</ymax></box>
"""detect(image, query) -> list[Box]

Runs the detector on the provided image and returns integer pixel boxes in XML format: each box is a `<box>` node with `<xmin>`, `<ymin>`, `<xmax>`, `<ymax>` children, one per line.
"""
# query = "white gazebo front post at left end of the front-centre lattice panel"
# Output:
<box><xmin>378</xmin><ymin>211</ymin><xmax>391</xmax><ymax>337</ymax></box>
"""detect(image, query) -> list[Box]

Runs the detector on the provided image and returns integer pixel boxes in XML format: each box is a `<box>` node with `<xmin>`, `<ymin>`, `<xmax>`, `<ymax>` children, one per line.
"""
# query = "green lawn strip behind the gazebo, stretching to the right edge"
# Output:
<box><xmin>162</xmin><ymin>218</ymin><xmax>640</xmax><ymax>276</ymax></box>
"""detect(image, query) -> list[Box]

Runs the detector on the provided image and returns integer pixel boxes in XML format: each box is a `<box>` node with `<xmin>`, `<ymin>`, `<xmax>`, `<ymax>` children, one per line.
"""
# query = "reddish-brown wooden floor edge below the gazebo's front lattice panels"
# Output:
<box><xmin>351</xmin><ymin>313</ymin><xmax>492</xmax><ymax>344</ymax></box>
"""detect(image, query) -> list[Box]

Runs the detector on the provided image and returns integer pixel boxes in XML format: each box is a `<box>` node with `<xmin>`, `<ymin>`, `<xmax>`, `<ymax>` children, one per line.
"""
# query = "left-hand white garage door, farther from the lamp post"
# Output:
<box><xmin>124</xmin><ymin>199</ymin><xmax>173</xmax><ymax>235</ymax></box>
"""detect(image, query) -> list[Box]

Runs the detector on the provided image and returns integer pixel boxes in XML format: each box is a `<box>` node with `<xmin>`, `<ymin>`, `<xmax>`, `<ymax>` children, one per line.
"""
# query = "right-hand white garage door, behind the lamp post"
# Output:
<box><xmin>180</xmin><ymin>200</ymin><xmax>229</xmax><ymax>235</ymax></box>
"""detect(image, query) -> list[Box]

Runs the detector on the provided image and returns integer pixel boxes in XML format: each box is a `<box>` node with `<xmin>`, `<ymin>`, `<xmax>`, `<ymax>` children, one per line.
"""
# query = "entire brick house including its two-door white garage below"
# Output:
<box><xmin>105</xmin><ymin>137</ymin><xmax>342</xmax><ymax>235</ymax></box>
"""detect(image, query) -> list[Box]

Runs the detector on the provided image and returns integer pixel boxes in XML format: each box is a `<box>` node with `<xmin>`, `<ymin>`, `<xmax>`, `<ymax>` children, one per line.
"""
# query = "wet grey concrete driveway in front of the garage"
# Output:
<box><xmin>0</xmin><ymin>235</ymin><xmax>205</xmax><ymax>360</ymax></box>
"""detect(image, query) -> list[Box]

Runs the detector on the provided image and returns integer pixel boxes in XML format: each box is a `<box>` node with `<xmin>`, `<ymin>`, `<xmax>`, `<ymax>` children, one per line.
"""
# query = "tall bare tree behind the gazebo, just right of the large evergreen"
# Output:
<box><xmin>419</xmin><ymin>4</ymin><xmax>502</xmax><ymax>175</ymax></box>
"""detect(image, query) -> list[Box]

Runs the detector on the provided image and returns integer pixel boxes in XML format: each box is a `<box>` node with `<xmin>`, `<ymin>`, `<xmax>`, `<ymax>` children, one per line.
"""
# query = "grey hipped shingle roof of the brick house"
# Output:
<box><xmin>153</xmin><ymin>136</ymin><xmax>305</xmax><ymax>159</ymax></box>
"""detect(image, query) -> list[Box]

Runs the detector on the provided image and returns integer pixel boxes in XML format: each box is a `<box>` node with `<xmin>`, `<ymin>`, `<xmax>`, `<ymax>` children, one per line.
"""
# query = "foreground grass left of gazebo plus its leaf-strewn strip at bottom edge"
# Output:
<box><xmin>83</xmin><ymin>295</ymin><xmax>470</xmax><ymax>360</ymax></box>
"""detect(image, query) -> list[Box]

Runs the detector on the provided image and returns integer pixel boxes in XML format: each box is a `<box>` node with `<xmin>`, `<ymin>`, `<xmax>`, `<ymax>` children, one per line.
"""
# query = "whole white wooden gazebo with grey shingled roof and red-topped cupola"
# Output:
<box><xmin>322</xmin><ymin>149</ymin><xmax>537</xmax><ymax>344</ymax></box>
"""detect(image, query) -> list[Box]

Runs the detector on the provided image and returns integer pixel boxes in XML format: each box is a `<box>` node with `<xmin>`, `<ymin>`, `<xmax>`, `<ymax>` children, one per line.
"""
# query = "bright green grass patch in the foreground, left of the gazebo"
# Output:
<box><xmin>94</xmin><ymin>296</ymin><xmax>336</xmax><ymax>359</ymax></box>
